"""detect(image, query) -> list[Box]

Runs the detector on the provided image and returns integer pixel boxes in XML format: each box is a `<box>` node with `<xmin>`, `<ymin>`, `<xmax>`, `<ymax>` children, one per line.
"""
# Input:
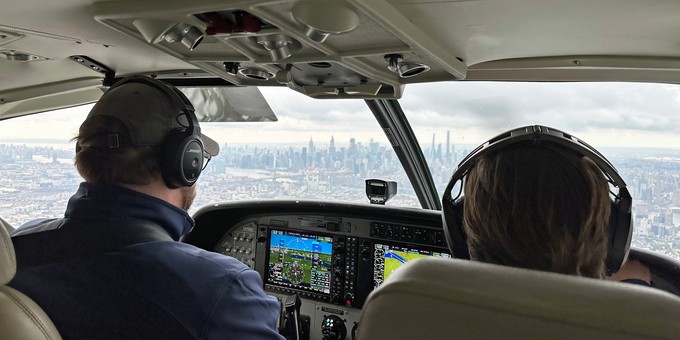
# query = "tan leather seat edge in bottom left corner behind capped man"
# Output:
<box><xmin>0</xmin><ymin>219</ymin><xmax>61</xmax><ymax>340</ymax></box>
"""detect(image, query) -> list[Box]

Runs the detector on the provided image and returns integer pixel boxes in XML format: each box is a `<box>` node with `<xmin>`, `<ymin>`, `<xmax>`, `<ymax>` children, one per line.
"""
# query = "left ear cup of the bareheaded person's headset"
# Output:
<box><xmin>442</xmin><ymin>197</ymin><xmax>470</xmax><ymax>260</ymax></box>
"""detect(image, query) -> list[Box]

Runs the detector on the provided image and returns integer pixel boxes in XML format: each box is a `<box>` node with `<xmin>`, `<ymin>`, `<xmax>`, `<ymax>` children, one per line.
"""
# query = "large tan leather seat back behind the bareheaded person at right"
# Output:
<box><xmin>358</xmin><ymin>258</ymin><xmax>680</xmax><ymax>340</ymax></box>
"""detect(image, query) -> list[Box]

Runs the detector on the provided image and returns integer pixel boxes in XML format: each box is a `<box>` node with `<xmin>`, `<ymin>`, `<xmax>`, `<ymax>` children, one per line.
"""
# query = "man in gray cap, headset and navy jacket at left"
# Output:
<box><xmin>10</xmin><ymin>76</ymin><xmax>282</xmax><ymax>339</ymax></box>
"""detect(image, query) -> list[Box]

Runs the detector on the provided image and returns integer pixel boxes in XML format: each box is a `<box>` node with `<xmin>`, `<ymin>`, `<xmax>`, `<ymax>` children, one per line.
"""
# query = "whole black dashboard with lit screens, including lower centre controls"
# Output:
<box><xmin>184</xmin><ymin>201</ymin><xmax>451</xmax><ymax>339</ymax></box>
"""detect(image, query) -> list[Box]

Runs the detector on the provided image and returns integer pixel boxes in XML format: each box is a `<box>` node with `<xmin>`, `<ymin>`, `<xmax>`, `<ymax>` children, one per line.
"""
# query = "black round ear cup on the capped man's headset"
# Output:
<box><xmin>161</xmin><ymin>128</ymin><xmax>203</xmax><ymax>188</ymax></box>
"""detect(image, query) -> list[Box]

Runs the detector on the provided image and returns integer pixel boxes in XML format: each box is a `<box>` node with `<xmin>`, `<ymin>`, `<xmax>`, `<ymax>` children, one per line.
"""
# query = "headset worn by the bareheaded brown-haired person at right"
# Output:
<box><xmin>442</xmin><ymin>125</ymin><xmax>633</xmax><ymax>275</ymax></box>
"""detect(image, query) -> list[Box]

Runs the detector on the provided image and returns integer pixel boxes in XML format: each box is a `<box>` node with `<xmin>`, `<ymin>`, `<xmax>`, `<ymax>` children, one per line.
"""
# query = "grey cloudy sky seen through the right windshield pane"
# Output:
<box><xmin>402</xmin><ymin>82</ymin><xmax>680</xmax><ymax>146</ymax></box>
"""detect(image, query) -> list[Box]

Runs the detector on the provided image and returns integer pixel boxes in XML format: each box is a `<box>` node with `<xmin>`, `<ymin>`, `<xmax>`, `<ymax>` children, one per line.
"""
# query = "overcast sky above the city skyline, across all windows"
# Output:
<box><xmin>0</xmin><ymin>82</ymin><xmax>680</xmax><ymax>148</ymax></box>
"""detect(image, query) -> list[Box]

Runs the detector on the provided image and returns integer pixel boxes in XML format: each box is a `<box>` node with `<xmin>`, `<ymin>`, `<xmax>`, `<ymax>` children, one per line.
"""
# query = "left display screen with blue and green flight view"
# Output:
<box><xmin>267</xmin><ymin>230</ymin><xmax>333</xmax><ymax>294</ymax></box>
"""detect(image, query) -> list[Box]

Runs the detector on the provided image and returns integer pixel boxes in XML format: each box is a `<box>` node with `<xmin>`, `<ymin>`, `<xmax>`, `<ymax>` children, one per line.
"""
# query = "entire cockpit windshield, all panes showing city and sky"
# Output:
<box><xmin>0</xmin><ymin>82</ymin><xmax>680</xmax><ymax>258</ymax></box>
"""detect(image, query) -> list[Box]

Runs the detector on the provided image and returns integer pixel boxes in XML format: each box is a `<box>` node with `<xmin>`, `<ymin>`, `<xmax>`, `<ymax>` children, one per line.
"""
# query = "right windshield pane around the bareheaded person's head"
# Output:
<box><xmin>400</xmin><ymin>82</ymin><xmax>680</xmax><ymax>258</ymax></box>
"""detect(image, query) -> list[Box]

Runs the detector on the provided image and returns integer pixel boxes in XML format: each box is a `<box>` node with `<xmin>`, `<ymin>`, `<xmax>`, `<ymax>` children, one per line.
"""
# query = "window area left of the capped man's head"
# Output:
<box><xmin>0</xmin><ymin>105</ymin><xmax>91</xmax><ymax>227</ymax></box>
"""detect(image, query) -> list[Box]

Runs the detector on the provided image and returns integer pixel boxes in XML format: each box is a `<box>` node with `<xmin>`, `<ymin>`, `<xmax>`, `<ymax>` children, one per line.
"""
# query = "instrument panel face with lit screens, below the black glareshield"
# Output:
<box><xmin>213</xmin><ymin>215</ymin><xmax>450</xmax><ymax>308</ymax></box>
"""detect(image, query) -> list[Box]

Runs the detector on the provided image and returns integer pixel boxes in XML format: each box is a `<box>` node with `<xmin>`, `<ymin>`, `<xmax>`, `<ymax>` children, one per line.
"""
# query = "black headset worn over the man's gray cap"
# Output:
<box><xmin>76</xmin><ymin>76</ymin><xmax>205</xmax><ymax>188</ymax></box>
